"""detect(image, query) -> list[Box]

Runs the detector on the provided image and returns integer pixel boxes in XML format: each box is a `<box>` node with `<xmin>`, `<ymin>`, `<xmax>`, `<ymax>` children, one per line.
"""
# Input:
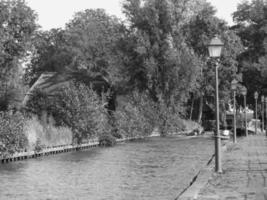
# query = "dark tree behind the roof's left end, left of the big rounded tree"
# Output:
<box><xmin>24</xmin><ymin>29</ymin><xmax>73</xmax><ymax>86</ymax></box>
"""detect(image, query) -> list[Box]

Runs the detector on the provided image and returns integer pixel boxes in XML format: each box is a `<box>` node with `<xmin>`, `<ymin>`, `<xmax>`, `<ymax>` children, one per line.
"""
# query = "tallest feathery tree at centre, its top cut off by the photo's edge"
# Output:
<box><xmin>120</xmin><ymin>0</ymin><xmax>204</xmax><ymax>135</ymax></box>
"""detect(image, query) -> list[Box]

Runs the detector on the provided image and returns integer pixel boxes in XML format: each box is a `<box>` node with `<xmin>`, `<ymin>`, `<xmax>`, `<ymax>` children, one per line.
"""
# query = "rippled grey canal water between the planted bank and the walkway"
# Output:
<box><xmin>0</xmin><ymin>136</ymin><xmax>214</xmax><ymax>200</ymax></box>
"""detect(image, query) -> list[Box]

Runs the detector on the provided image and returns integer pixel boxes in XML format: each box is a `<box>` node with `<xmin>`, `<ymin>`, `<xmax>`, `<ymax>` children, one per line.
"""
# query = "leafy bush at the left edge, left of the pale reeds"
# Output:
<box><xmin>0</xmin><ymin>112</ymin><xmax>28</xmax><ymax>155</ymax></box>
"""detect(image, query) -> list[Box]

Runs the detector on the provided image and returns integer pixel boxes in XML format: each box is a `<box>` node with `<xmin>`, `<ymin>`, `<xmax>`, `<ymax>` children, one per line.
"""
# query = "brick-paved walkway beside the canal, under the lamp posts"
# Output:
<box><xmin>197</xmin><ymin>135</ymin><xmax>267</xmax><ymax>200</ymax></box>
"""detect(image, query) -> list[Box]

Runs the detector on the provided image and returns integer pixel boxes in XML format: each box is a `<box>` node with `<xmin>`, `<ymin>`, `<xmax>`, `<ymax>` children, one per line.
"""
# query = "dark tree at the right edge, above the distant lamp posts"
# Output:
<box><xmin>233</xmin><ymin>0</ymin><xmax>267</xmax><ymax>104</ymax></box>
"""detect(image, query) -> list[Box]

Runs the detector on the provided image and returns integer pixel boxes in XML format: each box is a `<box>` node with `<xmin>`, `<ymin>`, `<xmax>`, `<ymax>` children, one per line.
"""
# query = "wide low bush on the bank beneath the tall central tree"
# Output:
<box><xmin>115</xmin><ymin>92</ymin><xmax>184</xmax><ymax>137</ymax></box>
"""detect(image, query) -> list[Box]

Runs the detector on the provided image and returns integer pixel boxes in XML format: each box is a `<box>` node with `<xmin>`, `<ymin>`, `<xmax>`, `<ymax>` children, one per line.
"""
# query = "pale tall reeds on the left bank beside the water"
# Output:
<box><xmin>24</xmin><ymin>116</ymin><xmax>72</xmax><ymax>150</ymax></box>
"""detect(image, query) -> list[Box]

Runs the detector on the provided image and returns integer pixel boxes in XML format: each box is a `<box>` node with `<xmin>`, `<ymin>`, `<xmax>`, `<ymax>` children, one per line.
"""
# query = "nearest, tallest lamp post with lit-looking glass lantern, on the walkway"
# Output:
<box><xmin>208</xmin><ymin>37</ymin><xmax>223</xmax><ymax>173</ymax></box>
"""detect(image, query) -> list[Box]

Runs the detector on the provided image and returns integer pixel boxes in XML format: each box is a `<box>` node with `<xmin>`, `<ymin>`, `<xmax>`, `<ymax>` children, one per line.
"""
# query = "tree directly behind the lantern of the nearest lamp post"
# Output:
<box><xmin>183</xmin><ymin>3</ymin><xmax>243</xmax><ymax>123</ymax></box>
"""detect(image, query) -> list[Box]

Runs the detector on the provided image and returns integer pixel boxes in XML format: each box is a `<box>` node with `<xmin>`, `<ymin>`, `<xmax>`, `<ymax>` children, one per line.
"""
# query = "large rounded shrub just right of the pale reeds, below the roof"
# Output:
<box><xmin>53</xmin><ymin>83</ymin><xmax>111</xmax><ymax>143</ymax></box>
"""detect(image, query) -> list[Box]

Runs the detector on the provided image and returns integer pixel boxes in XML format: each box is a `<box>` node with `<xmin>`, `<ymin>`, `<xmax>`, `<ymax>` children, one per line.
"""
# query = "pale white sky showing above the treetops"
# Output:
<box><xmin>26</xmin><ymin>0</ymin><xmax>246</xmax><ymax>30</ymax></box>
